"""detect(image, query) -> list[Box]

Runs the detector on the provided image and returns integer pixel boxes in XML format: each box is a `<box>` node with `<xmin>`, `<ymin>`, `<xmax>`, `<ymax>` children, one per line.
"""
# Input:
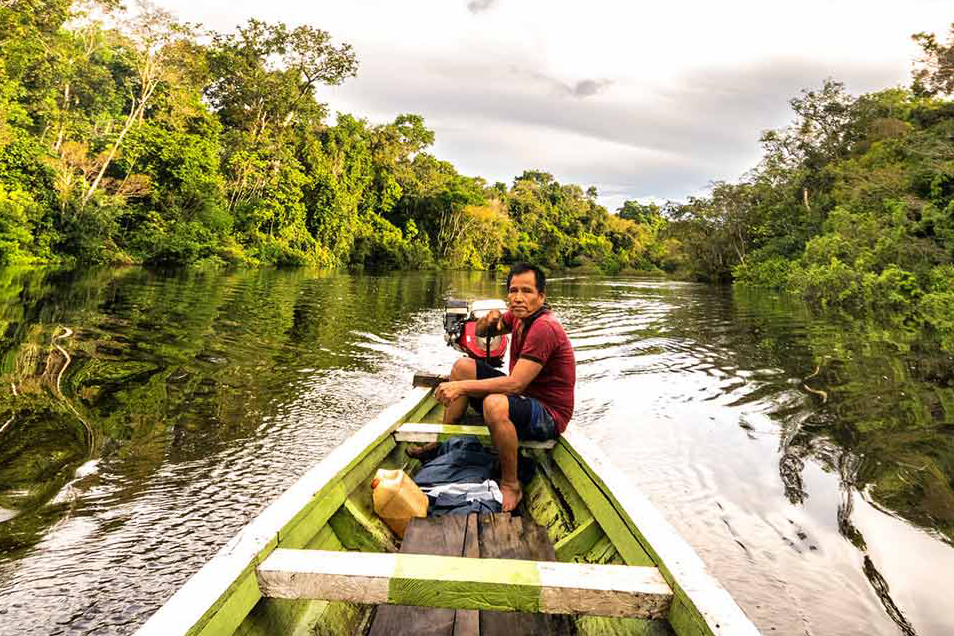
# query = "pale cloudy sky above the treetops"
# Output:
<box><xmin>157</xmin><ymin>0</ymin><xmax>954</xmax><ymax>214</ymax></box>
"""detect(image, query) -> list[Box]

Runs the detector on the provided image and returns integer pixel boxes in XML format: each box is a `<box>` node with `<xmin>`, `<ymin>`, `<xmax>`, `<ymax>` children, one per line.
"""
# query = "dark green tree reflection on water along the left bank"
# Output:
<box><xmin>0</xmin><ymin>268</ymin><xmax>448</xmax><ymax>557</ymax></box>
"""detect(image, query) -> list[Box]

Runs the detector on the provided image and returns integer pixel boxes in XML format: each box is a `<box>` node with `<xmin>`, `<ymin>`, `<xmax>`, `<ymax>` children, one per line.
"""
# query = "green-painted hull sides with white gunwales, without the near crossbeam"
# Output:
<box><xmin>138</xmin><ymin>388</ymin><xmax>758</xmax><ymax>636</ymax></box>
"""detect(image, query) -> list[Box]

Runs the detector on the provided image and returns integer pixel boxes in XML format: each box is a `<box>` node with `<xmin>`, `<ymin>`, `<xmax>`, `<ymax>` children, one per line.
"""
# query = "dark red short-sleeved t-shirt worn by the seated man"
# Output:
<box><xmin>503</xmin><ymin>309</ymin><xmax>576</xmax><ymax>433</ymax></box>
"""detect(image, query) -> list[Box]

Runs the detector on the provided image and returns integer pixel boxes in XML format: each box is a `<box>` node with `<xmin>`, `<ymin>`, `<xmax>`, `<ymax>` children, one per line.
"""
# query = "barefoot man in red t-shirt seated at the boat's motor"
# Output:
<box><xmin>434</xmin><ymin>263</ymin><xmax>576</xmax><ymax>512</ymax></box>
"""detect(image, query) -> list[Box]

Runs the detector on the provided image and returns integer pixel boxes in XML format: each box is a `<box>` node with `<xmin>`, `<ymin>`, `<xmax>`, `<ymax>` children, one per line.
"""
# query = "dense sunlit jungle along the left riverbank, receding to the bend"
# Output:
<box><xmin>0</xmin><ymin>0</ymin><xmax>664</xmax><ymax>271</ymax></box>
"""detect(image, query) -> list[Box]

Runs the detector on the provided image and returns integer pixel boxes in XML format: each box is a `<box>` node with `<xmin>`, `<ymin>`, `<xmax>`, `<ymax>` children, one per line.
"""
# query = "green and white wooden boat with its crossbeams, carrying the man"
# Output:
<box><xmin>138</xmin><ymin>380</ymin><xmax>759</xmax><ymax>636</ymax></box>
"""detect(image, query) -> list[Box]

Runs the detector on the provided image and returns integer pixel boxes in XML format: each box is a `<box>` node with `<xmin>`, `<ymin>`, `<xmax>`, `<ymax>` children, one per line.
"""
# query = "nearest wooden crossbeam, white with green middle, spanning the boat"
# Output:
<box><xmin>257</xmin><ymin>549</ymin><xmax>672</xmax><ymax>618</ymax></box>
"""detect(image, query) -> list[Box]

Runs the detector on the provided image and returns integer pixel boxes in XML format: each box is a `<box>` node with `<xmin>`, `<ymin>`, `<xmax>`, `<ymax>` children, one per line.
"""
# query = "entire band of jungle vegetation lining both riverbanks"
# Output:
<box><xmin>0</xmin><ymin>0</ymin><xmax>954</xmax><ymax>338</ymax></box>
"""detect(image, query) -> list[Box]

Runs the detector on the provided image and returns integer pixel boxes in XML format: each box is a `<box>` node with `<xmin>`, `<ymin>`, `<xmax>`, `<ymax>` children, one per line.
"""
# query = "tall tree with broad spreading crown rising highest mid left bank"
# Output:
<box><xmin>205</xmin><ymin>19</ymin><xmax>357</xmax><ymax>264</ymax></box>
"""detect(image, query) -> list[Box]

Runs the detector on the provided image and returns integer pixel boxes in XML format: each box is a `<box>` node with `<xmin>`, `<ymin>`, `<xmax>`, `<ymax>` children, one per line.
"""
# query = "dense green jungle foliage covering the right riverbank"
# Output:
<box><xmin>669</xmin><ymin>25</ymin><xmax>954</xmax><ymax>348</ymax></box>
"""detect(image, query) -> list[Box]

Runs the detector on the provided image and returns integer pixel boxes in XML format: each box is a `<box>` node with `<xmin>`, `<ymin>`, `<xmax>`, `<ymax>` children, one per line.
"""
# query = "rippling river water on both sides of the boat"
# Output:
<box><xmin>0</xmin><ymin>268</ymin><xmax>954</xmax><ymax>636</ymax></box>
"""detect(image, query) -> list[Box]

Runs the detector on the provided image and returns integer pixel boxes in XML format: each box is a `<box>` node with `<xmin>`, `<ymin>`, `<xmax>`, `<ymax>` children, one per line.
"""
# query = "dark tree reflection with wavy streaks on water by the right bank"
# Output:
<box><xmin>660</xmin><ymin>293</ymin><xmax>954</xmax><ymax>634</ymax></box>
